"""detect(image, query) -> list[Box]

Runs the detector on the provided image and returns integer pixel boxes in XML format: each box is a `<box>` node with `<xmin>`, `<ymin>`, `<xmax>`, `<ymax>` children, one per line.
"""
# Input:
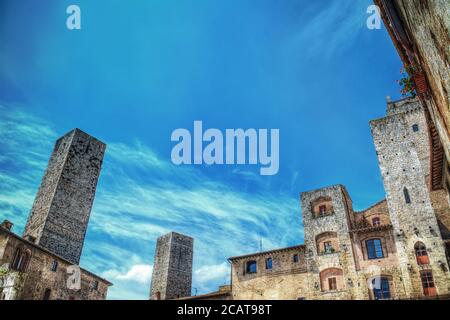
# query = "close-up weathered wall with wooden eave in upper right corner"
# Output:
<box><xmin>374</xmin><ymin>0</ymin><xmax>450</xmax><ymax>171</ymax></box>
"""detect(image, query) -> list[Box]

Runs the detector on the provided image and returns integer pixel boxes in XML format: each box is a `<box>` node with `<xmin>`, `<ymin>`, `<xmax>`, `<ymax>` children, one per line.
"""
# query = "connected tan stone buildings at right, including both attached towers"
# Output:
<box><xmin>184</xmin><ymin>98</ymin><xmax>450</xmax><ymax>299</ymax></box>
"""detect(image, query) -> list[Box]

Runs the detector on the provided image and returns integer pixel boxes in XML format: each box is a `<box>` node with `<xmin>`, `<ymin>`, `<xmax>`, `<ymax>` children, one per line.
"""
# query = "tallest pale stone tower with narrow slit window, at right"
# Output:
<box><xmin>370</xmin><ymin>99</ymin><xmax>450</xmax><ymax>297</ymax></box>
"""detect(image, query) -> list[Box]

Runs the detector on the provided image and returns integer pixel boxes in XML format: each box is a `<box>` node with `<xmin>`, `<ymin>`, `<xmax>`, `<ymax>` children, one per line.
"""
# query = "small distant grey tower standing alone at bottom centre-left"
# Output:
<box><xmin>150</xmin><ymin>232</ymin><xmax>194</xmax><ymax>300</ymax></box>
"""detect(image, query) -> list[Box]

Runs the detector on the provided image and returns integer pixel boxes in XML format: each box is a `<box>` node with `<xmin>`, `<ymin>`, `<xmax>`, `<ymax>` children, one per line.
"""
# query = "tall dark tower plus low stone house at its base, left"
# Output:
<box><xmin>0</xmin><ymin>129</ymin><xmax>111</xmax><ymax>300</ymax></box>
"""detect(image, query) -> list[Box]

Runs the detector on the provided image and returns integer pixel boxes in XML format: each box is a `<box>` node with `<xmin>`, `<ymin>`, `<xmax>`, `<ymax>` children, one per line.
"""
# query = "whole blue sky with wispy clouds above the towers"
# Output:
<box><xmin>0</xmin><ymin>0</ymin><xmax>401</xmax><ymax>299</ymax></box>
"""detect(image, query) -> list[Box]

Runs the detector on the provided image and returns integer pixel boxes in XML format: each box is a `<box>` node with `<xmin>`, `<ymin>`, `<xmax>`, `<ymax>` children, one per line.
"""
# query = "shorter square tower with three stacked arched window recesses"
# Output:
<box><xmin>300</xmin><ymin>185</ymin><xmax>364</xmax><ymax>299</ymax></box>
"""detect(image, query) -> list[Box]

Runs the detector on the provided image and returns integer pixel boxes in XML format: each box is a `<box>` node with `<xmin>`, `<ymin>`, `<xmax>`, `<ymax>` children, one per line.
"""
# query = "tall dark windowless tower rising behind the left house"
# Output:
<box><xmin>23</xmin><ymin>129</ymin><xmax>106</xmax><ymax>264</ymax></box>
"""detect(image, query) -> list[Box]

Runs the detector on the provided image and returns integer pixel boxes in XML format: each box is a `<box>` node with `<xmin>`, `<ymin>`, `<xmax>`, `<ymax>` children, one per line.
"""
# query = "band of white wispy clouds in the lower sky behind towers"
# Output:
<box><xmin>0</xmin><ymin>107</ymin><xmax>302</xmax><ymax>299</ymax></box>
